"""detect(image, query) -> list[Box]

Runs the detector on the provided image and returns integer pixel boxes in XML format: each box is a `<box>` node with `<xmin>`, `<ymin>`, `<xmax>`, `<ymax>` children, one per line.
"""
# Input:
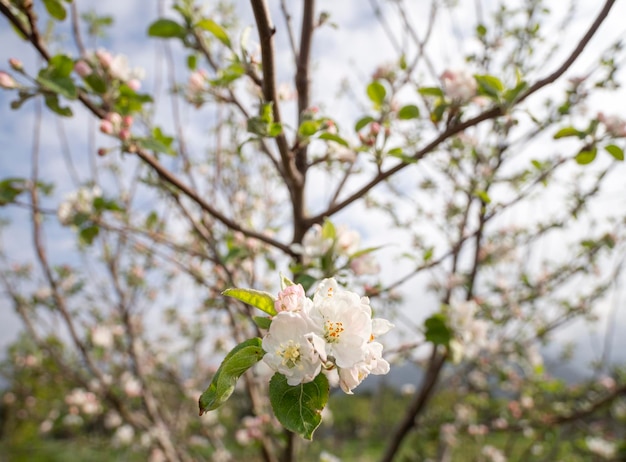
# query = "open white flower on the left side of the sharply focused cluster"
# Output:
<box><xmin>262</xmin><ymin>311</ymin><xmax>322</xmax><ymax>386</ymax></box>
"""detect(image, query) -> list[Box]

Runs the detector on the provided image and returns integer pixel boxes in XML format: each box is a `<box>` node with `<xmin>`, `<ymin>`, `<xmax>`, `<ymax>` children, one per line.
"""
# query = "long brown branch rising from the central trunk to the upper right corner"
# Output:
<box><xmin>306</xmin><ymin>0</ymin><xmax>615</xmax><ymax>226</ymax></box>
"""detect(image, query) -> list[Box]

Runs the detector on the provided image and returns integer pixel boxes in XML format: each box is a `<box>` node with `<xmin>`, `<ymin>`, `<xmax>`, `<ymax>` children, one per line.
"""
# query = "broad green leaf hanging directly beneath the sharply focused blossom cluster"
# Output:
<box><xmin>270</xmin><ymin>373</ymin><xmax>329</xmax><ymax>440</ymax></box>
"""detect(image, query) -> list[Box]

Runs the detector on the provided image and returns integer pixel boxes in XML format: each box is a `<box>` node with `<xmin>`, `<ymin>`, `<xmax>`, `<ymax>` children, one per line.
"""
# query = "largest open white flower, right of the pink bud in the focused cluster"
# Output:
<box><xmin>309</xmin><ymin>279</ymin><xmax>372</xmax><ymax>368</ymax></box>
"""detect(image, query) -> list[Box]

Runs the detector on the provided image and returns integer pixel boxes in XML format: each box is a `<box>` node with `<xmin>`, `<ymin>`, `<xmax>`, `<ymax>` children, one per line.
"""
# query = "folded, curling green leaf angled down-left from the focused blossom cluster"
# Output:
<box><xmin>198</xmin><ymin>338</ymin><xmax>265</xmax><ymax>415</ymax></box>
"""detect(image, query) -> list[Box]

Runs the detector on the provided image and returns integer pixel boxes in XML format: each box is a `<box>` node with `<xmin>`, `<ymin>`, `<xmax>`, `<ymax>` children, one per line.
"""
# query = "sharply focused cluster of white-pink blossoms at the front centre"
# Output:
<box><xmin>262</xmin><ymin>278</ymin><xmax>393</xmax><ymax>394</ymax></box>
